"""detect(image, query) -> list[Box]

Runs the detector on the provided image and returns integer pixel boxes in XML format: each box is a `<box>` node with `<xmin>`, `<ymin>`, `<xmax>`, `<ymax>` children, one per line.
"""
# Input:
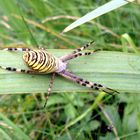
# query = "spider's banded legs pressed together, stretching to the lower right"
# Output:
<box><xmin>58</xmin><ymin>71</ymin><xmax>119</xmax><ymax>94</ymax></box>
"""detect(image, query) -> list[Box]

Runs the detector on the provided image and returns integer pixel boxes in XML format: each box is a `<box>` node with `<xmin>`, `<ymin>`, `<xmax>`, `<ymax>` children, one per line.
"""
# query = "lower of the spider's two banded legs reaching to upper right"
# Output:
<box><xmin>62</xmin><ymin>49</ymin><xmax>99</xmax><ymax>62</ymax></box>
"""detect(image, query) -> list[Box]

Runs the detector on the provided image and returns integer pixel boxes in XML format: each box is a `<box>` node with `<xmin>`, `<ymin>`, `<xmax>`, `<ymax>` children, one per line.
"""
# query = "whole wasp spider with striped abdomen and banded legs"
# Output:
<box><xmin>0</xmin><ymin>41</ymin><xmax>118</xmax><ymax>106</ymax></box>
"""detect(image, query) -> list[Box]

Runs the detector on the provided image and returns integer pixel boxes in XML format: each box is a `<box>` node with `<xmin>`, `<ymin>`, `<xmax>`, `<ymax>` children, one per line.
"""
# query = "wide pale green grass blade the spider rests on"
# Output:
<box><xmin>0</xmin><ymin>49</ymin><xmax>140</xmax><ymax>94</ymax></box>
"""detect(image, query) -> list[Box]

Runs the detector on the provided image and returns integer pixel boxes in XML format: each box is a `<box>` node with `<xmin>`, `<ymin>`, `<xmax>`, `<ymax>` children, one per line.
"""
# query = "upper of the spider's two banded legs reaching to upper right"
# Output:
<box><xmin>60</xmin><ymin>41</ymin><xmax>94</xmax><ymax>62</ymax></box>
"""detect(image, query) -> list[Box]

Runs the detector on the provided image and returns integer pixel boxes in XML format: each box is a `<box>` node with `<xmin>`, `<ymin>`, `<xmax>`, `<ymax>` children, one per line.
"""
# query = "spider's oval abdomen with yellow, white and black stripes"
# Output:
<box><xmin>23</xmin><ymin>50</ymin><xmax>59</xmax><ymax>73</ymax></box>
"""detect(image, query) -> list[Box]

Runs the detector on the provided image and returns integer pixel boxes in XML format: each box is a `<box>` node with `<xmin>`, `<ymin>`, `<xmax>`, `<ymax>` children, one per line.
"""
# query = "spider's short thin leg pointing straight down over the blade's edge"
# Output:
<box><xmin>44</xmin><ymin>73</ymin><xmax>55</xmax><ymax>108</ymax></box>
